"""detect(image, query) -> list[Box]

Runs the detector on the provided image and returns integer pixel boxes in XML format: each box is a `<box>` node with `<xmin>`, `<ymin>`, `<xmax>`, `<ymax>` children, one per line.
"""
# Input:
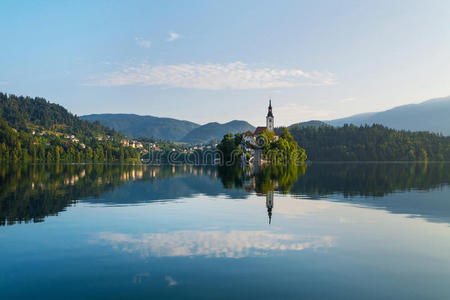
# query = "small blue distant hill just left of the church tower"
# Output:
<box><xmin>182</xmin><ymin>120</ymin><xmax>255</xmax><ymax>143</ymax></box>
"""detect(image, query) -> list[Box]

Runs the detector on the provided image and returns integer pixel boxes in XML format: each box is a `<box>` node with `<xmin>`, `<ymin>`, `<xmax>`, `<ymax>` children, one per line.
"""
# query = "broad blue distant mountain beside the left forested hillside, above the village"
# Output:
<box><xmin>80</xmin><ymin>114</ymin><xmax>200</xmax><ymax>141</ymax></box>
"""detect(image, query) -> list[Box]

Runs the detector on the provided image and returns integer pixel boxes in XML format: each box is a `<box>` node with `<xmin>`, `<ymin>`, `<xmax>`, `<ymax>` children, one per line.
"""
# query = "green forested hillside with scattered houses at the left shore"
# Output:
<box><xmin>0</xmin><ymin>93</ymin><xmax>139</xmax><ymax>162</ymax></box>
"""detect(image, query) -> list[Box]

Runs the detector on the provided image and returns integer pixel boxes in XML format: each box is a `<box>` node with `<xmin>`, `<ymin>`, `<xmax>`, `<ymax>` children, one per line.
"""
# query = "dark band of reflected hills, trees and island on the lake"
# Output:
<box><xmin>0</xmin><ymin>163</ymin><xmax>450</xmax><ymax>225</ymax></box>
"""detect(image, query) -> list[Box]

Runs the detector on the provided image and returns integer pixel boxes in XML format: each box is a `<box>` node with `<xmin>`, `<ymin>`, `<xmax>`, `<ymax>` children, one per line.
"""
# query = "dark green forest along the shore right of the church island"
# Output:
<box><xmin>284</xmin><ymin>125</ymin><xmax>450</xmax><ymax>161</ymax></box>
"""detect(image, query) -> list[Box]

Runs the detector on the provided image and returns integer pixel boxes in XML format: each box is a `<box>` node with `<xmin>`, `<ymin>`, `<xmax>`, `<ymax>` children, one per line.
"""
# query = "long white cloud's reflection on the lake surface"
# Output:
<box><xmin>95</xmin><ymin>231</ymin><xmax>333</xmax><ymax>258</ymax></box>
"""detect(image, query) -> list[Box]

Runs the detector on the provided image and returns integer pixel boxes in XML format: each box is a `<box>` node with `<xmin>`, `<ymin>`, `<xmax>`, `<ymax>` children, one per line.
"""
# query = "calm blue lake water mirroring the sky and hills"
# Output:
<box><xmin>0</xmin><ymin>163</ymin><xmax>450</xmax><ymax>299</ymax></box>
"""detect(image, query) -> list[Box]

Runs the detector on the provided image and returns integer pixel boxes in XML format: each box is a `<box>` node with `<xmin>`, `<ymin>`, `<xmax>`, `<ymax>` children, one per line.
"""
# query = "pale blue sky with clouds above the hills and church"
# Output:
<box><xmin>0</xmin><ymin>0</ymin><xmax>450</xmax><ymax>125</ymax></box>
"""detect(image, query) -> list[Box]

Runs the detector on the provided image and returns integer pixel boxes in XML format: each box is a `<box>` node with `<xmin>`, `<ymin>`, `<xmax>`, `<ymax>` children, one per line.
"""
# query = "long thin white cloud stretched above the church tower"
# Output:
<box><xmin>88</xmin><ymin>61</ymin><xmax>336</xmax><ymax>90</ymax></box>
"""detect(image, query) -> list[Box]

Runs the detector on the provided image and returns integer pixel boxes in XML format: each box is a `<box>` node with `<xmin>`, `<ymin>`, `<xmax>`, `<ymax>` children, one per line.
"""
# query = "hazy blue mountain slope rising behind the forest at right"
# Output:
<box><xmin>327</xmin><ymin>96</ymin><xmax>450</xmax><ymax>135</ymax></box>
